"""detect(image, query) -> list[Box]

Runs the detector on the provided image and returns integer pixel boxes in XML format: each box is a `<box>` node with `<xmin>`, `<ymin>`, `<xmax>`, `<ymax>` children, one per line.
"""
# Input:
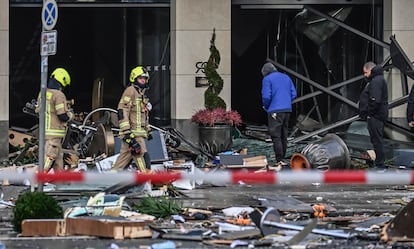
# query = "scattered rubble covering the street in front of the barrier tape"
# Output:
<box><xmin>0</xmin><ymin>178</ymin><xmax>414</xmax><ymax>248</ymax></box>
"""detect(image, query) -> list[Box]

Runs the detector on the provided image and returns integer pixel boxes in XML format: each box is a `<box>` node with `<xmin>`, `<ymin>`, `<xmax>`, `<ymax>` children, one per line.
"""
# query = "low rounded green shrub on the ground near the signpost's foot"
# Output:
<box><xmin>13</xmin><ymin>192</ymin><xmax>63</xmax><ymax>232</ymax></box>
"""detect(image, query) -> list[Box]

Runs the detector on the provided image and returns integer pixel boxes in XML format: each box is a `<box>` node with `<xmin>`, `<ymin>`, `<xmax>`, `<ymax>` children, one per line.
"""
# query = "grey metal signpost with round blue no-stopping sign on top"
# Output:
<box><xmin>38</xmin><ymin>0</ymin><xmax>58</xmax><ymax>192</ymax></box>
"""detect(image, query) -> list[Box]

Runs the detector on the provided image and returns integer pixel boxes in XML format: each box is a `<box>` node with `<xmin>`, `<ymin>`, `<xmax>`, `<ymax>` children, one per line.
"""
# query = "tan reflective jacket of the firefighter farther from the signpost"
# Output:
<box><xmin>118</xmin><ymin>85</ymin><xmax>149</xmax><ymax>137</ymax></box>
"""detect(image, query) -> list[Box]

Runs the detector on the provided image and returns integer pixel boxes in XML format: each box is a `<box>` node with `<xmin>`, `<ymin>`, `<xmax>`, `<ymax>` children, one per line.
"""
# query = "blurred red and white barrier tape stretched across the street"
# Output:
<box><xmin>0</xmin><ymin>170</ymin><xmax>414</xmax><ymax>185</ymax></box>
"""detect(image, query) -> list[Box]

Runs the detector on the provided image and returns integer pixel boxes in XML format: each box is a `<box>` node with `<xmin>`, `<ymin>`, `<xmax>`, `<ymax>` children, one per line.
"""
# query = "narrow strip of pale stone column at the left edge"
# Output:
<box><xmin>0</xmin><ymin>1</ymin><xmax>9</xmax><ymax>159</ymax></box>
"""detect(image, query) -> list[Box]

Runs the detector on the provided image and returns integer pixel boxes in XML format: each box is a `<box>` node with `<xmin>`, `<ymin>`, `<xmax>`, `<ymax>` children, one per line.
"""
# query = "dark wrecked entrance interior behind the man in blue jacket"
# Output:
<box><xmin>232</xmin><ymin>4</ymin><xmax>382</xmax><ymax>130</ymax></box>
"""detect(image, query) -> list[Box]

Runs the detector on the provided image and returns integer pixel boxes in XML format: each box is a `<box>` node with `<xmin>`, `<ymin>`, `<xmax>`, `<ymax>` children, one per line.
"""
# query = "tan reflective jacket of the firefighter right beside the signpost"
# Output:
<box><xmin>38</xmin><ymin>88</ymin><xmax>74</xmax><ymax>139</ymax></box>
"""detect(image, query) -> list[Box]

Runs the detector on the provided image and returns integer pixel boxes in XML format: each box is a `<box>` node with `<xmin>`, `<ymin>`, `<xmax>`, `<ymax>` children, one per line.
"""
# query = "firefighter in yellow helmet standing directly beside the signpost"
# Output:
<box><xmin>38</xmin><ymin>68</ymin><xmax>74</xmax><ymax>171</ymax></box>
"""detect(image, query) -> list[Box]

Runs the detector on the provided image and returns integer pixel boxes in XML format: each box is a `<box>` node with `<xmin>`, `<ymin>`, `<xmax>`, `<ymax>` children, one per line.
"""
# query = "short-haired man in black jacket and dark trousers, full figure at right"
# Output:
<box><xmin>359</xmin><ymin>61</ymin><xmax>388</xmax><ymax>169</ymax></box>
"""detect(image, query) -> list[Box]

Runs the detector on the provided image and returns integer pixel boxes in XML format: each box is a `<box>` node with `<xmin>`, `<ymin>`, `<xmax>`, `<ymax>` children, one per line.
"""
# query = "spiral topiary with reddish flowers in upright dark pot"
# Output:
<box><xmin>191</xmin><ymin>29</ymin><xmax>242</xmax><ymax>155</ymax></box>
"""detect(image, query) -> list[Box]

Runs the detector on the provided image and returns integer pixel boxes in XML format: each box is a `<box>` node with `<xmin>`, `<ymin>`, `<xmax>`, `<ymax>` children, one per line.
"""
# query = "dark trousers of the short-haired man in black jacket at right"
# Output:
<box><xmin>367</xmin><ymin>117</ymin><xmax>385</xmax><ymax>168</ymax></box>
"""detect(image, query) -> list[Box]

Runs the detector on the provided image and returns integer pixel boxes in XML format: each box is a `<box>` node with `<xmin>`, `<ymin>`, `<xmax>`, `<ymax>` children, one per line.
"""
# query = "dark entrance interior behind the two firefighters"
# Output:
<box><xmin>10</xmin><ymin>3</ymin><xmax>170</xmax><ymax>128</ymax></box>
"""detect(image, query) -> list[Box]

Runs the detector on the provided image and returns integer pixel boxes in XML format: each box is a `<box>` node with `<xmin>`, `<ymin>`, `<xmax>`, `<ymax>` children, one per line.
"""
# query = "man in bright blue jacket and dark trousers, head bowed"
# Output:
<box><xmin>262</xmin><ymin>62</ymin><xmax>296</xmax><ymax>165</ymax></box>
